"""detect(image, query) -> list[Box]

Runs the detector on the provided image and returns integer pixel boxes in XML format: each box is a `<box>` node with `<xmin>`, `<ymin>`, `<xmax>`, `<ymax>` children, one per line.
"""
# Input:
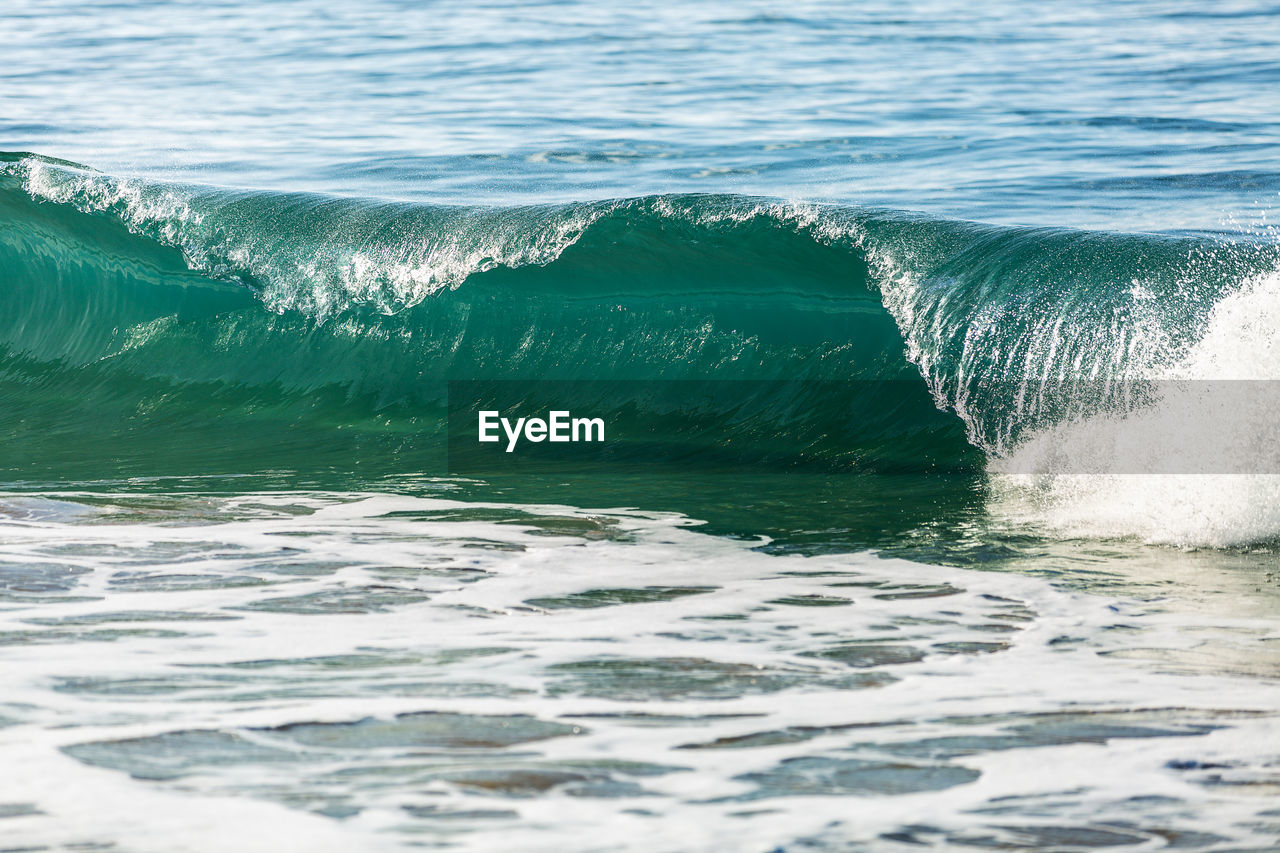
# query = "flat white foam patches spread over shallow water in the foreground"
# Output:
<box><xmin>0</xmin><ymin>494</ymin><xmax>1280</xmax><ymax>850</ymax></box>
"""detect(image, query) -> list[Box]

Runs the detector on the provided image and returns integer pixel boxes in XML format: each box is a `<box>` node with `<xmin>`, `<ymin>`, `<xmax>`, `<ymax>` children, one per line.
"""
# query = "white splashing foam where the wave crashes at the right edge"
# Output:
<box><xmin>991</xmin><ymin>273</ymin><xmax>1280</xmax><ymax>547</ymax></box>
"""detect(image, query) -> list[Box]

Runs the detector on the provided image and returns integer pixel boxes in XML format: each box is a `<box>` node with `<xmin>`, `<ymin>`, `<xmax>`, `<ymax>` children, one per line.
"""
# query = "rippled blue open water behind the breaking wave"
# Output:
<box><xmin>0</xmin><ymin>0</ymin><xmax>1280</xmax><ymax>231</ymax></box>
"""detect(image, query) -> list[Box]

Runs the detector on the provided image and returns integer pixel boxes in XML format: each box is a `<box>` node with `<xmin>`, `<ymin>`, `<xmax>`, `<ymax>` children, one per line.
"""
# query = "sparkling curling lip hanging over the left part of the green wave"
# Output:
<box><xmin>5</xmin><ymin>155</ymin><xmax>603</xmax><ymax>319</ymax></box>
